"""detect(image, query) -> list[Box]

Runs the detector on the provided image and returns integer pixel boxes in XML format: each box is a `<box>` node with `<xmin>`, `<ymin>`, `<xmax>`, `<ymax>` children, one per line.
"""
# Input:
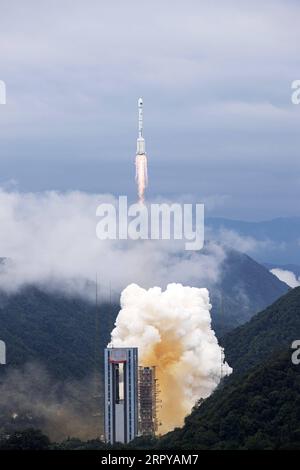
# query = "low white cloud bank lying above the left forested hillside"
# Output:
<box><xmin>0</xmin><ymin>190</ymin><xmax>226</xmax><ymax>296</ymax></box>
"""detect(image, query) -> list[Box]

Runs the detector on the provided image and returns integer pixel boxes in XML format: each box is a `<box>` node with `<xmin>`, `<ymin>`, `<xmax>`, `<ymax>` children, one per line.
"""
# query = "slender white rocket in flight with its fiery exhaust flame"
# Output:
<box><xmin>135</xmin><ymin>98</ymin><xmax>148</xmax><ymax>204</ymax></box>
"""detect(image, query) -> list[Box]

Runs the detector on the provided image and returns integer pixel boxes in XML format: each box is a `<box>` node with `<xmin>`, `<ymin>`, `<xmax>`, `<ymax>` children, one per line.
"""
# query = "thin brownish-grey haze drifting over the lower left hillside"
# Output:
<box><xmin>0</xmin><ymin>363</ymin><xmax>103</xmax><ymax>441</ymax></box>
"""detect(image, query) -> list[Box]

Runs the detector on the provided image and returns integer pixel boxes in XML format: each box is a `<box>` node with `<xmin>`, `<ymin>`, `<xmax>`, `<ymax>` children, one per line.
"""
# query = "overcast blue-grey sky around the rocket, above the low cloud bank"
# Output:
<box><xmin>0</xmin><ymin>0</ymin><xmax>300</xmax><ymax>220</ymax></box>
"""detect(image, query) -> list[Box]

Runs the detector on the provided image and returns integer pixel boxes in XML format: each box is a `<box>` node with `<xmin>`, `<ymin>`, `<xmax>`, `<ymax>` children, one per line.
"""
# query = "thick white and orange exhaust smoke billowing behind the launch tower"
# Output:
<box><xmin>111</xmin><ymin>284</ymin><xmax>231</xmax><ymax>432</ymax></box>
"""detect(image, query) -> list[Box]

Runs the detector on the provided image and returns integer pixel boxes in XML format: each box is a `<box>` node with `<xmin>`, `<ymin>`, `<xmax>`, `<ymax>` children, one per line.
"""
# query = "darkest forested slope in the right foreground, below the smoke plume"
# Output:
<box><xmin>155</xmin><ymin>351</ymin><xmax>300</xmax><ymax>450</ymax></box>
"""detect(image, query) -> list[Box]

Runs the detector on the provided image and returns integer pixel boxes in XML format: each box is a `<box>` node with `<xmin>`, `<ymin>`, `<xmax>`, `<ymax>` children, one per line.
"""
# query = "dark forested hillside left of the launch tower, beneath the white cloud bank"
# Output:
<box><xmin>0</xmin><ymin>287</ymin><xmax>118</xmax><ymax>379</ymax></box>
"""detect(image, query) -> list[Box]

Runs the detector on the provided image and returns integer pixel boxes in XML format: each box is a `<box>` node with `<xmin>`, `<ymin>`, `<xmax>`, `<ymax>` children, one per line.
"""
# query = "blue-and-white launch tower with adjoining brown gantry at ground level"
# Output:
<box><xmin>104</xmin><ymin>348</ymin><xmax>158</xmax><ymax>444</ymax></box>
